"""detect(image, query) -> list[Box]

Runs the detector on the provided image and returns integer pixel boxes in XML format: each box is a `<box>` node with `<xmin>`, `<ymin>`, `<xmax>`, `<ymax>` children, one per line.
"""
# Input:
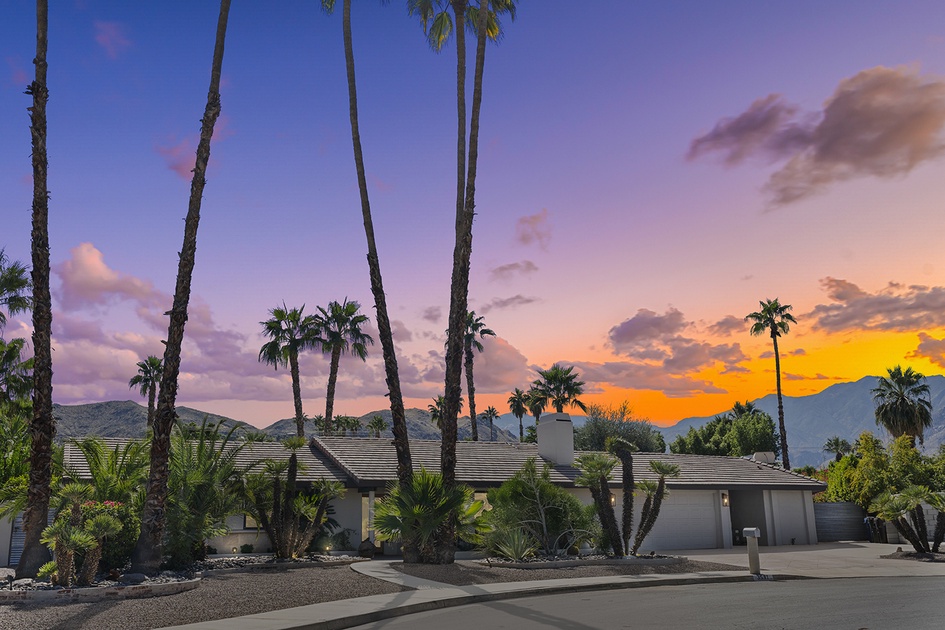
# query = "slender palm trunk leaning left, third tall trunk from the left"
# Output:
<box><xmin>342</xmin><ymin>0</ymin><xmax>413</xmax><ymax>484</ymax></box>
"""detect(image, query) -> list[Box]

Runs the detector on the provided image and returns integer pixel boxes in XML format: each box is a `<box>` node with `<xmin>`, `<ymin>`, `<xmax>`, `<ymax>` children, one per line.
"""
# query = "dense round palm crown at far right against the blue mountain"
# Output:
<box><xmin>870</xmin><ymin>365</ymin><xmax>932</xmax><ymax>444</ymax></box>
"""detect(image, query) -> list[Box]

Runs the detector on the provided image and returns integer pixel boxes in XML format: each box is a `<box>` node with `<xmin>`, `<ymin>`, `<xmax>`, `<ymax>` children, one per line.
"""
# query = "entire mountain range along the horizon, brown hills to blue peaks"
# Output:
<box><xmin>53</xmin><ymin>376</ymin><xmax>945</xmax><ymax>466</ymax></box>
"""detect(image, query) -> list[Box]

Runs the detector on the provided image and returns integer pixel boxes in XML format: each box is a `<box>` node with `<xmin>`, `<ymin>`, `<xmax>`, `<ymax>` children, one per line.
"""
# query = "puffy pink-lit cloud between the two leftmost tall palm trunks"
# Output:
<box><xmin>52</xmin><ymin>243</ymin><xmax>165</xmax><ymax>310</ymax></box>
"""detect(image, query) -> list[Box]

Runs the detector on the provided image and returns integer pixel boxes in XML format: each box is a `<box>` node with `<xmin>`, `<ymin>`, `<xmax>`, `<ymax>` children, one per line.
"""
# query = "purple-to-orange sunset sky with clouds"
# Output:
<box><xmin>0</xmin><ymin>0</ymin><xmax>945</xmax><ymax>426</ymax></box>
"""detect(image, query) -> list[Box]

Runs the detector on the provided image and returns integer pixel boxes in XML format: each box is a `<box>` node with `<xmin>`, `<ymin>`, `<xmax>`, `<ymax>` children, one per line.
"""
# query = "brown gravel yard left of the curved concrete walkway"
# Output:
<box><xmin>0</xmin><ymin>566</ymin><xmax>408</xmax><ymax>630</ymax></box>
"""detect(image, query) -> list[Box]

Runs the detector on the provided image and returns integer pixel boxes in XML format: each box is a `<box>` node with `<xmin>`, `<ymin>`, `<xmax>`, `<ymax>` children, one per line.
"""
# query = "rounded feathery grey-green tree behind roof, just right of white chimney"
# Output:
<box><xmin>574</xmin><ymin>401</ymin><xmax>666</xmax><ymax>453</ymax></box>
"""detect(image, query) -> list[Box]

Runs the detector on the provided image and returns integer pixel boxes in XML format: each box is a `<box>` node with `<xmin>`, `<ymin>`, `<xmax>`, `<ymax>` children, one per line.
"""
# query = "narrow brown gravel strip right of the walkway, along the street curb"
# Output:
<box><xmin>391</xmin><ymin>560</ymin><xmax>745</xmax><ymax>586</ymax></box>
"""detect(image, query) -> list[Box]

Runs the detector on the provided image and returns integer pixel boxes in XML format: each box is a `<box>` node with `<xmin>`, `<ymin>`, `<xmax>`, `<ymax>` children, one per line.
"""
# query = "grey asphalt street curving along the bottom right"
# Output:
<box><xmin>350</xmin><ymin>577</ymin><xmax>945</xmax><ymax>630</ymax></box>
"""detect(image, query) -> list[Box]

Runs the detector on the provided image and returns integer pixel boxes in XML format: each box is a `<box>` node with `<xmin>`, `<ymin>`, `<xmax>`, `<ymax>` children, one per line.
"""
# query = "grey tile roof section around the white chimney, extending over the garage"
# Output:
<box><xmin>312</xmin><ymin>437</ymin><xmax>826</xmax><ymax>492</ymax></box>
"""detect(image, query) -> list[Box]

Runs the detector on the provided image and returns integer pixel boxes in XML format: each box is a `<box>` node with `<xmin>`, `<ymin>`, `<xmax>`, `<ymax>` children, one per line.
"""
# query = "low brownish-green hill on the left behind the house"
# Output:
<box><xmin>53</xmin><ymin>400</ymin><xmax>254</xmax><ymax>442</ymax></box>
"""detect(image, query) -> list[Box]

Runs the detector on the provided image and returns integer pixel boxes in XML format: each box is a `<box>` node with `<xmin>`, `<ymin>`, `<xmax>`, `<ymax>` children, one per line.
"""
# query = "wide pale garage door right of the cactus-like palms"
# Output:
<box><xmin>637</xmin><ymin>490</ymin><xmax>722</xmax><ymax>552</ymax></box>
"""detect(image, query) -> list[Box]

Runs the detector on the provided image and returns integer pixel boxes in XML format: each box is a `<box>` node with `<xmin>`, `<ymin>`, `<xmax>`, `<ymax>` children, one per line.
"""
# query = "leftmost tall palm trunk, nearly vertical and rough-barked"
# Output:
<box><xmin>16</xmin><ymin>0</ymin><xmax>56</xmax><ymax>578</ymax></box>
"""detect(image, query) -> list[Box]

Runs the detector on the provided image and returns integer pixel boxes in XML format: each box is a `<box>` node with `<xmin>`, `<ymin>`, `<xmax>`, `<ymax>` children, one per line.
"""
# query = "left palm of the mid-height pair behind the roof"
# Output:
<box><xmin>259</xmin><ymin>302</ymin><xmax>319</xmax><ymax>438</ymax></box>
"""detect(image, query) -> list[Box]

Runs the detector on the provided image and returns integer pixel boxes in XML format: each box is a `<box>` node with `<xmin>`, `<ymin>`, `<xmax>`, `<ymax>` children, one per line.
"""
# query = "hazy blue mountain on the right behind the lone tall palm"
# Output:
<box><xmin>660</xmin><ymin>376</ymin><xmax>945</xmax><ymax>466</ymax></box>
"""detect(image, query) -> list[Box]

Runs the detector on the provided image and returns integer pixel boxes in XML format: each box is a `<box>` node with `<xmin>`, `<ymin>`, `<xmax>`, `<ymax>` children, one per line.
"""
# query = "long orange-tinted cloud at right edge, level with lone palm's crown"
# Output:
<box><xmin>804</xmin><ymin>277</ymin><xmax>945</xmax><ymax>332</ymax></box>
